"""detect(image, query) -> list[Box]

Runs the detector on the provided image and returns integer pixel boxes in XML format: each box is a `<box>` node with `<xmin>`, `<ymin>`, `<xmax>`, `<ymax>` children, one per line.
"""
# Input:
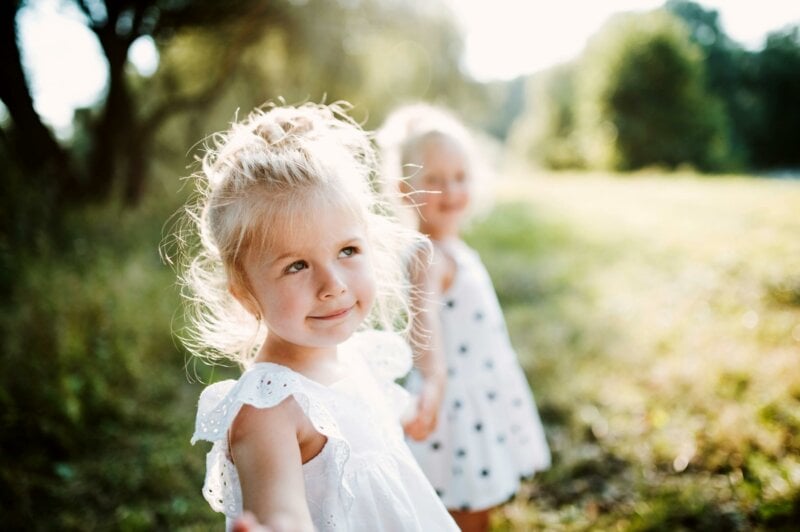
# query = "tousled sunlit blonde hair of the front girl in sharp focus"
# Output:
<box><xmin>173</xmin><ymin>102</ymin><xmax>423</xmax><ymax>366</ymax></box>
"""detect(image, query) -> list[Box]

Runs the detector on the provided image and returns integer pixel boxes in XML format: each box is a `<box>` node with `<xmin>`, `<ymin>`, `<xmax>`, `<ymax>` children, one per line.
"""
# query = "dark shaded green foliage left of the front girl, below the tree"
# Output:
<box><xmin>0</xmin><ymin>194</ymin><xmax>219</xmax><ymax>530</ymax></box>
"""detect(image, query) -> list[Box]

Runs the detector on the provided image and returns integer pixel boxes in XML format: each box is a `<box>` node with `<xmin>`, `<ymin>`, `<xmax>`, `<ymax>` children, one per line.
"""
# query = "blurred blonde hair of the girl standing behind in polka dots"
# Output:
<box><xmin>377</xmin><ymin>102</ymin><xmax>490</xmax><ymax>224</ymax></box>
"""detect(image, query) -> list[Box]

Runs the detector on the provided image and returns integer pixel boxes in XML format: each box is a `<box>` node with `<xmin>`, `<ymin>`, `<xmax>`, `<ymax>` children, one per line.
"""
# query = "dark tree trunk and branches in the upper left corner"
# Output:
<box><xmin>0</xmin><ymin>0</ymin><xmax>300</xmax><ymax>203</ymax></box>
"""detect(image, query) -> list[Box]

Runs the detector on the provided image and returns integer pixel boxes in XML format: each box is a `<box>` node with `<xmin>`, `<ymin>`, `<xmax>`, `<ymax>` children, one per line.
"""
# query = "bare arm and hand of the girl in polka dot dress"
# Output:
<box><xmin>404</xmin><ymin>245</ymin><xmax>445</xmax><ymax>440</ymax></box>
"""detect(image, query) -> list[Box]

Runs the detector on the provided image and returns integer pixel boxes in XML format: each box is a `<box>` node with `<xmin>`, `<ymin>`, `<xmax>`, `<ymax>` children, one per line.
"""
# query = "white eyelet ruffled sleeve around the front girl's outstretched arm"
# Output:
<box><xmin>192</xmin><ymin>363</ymin><xmax>353</xmax><ymax>517</ymax></box>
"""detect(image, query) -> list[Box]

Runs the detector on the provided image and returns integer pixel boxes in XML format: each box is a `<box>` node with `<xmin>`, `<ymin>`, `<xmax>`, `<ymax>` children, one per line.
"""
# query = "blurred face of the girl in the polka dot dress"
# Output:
<box><xmin>410</xmin><ymin>137</ymin><xmax>470</xmax><ymax>240</ymax></box>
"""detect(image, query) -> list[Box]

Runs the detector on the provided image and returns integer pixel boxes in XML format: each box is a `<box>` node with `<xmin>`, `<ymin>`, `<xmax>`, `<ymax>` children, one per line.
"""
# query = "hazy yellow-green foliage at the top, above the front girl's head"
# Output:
<box><xmin>141</xmin><ymin>0</ymin><xmax>482</xmax><ymax>140</ymax></box>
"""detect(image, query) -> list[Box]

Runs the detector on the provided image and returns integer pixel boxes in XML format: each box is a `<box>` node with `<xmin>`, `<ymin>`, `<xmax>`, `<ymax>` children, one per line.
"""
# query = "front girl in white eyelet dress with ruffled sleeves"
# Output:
<box><xmin>183</xmin><ymin>104</ymin><xmax>456</xmax><ymax>531</ymax></box>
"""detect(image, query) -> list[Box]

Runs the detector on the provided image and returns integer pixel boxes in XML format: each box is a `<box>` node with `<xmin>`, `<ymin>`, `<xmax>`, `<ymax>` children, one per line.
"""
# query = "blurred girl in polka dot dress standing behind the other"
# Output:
<box><xmin>379</xmin><ymin>104</ymin><xmax>550</xmax><ymax>531</ymax></box>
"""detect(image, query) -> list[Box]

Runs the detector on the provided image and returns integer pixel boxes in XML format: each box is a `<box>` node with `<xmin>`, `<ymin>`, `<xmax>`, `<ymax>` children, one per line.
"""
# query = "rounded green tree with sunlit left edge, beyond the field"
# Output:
<box><xmin>578</xmin><ymin>10</ymin><xmax>728</xmax><ymax>171</ymax></box>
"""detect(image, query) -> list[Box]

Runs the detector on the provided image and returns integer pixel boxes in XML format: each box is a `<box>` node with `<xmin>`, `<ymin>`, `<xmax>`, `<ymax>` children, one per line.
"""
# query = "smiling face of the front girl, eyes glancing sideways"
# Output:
<box><xmin>240</xmin><ymin>199</ymin><xmax>376</xmax><ymax>356</ymax></box>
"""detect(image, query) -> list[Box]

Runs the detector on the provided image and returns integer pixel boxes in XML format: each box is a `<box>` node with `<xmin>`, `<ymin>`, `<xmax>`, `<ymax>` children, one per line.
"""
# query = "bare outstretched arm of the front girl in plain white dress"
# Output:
<box><xmin>231</xmin><ymin>398</ymin><xmax>314</xmax><ymax>532</ymax></box>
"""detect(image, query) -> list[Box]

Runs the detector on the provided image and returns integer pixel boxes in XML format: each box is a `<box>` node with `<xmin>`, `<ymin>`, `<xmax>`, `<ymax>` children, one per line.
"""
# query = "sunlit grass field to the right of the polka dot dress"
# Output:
<box><xmin>468</xmin><ymin>175</ymin><xmax>800</xmax><ymax>531</ymax></box>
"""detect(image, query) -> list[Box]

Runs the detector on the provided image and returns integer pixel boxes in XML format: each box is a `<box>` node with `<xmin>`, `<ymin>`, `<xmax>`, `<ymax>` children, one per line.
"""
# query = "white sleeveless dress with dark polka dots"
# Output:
<box><xmin>407</xmin><ymin>242</ymin><xmax>550</xmax><ymax>511</ymax></box>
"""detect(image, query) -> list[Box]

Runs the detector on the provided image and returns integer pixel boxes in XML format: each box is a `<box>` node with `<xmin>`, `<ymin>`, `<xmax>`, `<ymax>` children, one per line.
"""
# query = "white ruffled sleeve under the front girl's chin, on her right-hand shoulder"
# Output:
<box><xmin>342</xmin><ymin>330</ymin><xmax>412</xmax><ymax>418</ymax></box>
